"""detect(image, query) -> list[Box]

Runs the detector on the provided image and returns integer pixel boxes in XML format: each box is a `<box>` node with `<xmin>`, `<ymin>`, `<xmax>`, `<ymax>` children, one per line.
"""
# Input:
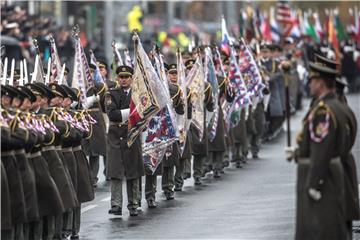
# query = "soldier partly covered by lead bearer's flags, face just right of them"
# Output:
<box><xmin>161</xmin><ymin>64</ymin><xmax>185</xmax><ymax>200</ymax></box>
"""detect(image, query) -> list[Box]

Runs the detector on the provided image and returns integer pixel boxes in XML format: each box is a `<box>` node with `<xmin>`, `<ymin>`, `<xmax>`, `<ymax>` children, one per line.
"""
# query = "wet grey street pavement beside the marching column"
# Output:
<box><xmin>80</xmin><ymin>95</ymin><xmax>360</xmax><ymax>240</ymax></box>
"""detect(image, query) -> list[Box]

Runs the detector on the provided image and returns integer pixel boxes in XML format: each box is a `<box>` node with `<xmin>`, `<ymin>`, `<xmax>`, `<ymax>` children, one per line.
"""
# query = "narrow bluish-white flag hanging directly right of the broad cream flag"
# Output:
<box><xmin>205</xmin><ymin>47</ymin><xmax>219</xmax><ymax>142</ymax></box>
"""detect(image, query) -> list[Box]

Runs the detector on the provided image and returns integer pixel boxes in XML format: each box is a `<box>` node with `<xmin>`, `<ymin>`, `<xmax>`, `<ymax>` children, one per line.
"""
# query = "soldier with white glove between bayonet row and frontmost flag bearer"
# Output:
<box><xmin>82</xmin><ymin>64</ymin><xmax>106</xmax><ymax>187</ymax></box>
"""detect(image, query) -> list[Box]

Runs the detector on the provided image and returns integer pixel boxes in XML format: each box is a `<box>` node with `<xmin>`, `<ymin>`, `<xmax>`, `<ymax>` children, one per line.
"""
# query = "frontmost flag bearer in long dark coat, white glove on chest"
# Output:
<box><xmin>105</xmin><ymin>66</ymin><xmax>144</xmax><ymax>216</ymax></box>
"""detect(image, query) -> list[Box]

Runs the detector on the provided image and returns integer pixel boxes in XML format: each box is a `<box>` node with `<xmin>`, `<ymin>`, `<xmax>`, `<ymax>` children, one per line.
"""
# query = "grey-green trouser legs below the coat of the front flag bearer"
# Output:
<box><xmin>110</xmin><ymin>178</ymin><xmax>139</xmax><ymax>209</ymax></box>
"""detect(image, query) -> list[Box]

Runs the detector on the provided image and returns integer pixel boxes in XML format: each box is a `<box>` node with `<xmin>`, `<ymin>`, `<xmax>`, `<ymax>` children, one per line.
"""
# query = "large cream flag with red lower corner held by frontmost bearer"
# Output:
<box><xmin>128</xmin><ymin>35</ymin><xmax>168</xmax><ymax>146</ymax></box>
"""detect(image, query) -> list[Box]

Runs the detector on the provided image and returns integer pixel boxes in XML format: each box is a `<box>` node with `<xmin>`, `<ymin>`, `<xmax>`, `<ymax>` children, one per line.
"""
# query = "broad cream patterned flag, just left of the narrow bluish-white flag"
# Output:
<box><xmin>186</xmin><ymin>56</ymin><xmax>205</xmax><ymax>140</ymax></box>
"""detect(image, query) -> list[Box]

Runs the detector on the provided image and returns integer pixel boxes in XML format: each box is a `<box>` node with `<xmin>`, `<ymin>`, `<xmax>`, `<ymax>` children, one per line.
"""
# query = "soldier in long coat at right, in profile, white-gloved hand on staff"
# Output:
<box><xmin>286</xmin><ymin>63</ymin><xmax>355</xmax><ymax>239</ymax></box>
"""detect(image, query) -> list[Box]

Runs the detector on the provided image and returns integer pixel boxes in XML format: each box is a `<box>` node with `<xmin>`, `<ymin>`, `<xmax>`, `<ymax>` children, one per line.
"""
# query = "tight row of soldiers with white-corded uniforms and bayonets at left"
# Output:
<box><xmin>0</xmin><ymin>67</ymin><xmax>97</xmax><ymax>240</ymax></box>
